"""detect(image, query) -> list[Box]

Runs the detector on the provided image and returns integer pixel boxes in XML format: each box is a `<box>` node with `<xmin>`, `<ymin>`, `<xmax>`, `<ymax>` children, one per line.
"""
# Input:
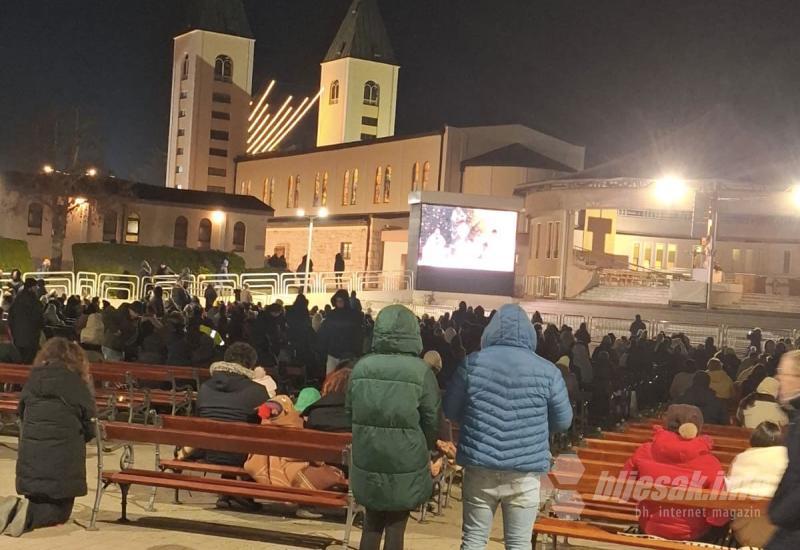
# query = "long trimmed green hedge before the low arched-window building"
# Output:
<box><xmin>72</xmin><ymin>243</ymin><xmax>245</xmax><ymax>274</ymax></box>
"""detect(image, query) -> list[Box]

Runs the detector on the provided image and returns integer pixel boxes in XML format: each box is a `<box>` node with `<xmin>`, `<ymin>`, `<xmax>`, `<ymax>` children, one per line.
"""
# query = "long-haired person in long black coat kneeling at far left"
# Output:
<box><xmin>0</xmin><ymin>338</ymin><xmax>96</xmax><ymax>536</ymax></box>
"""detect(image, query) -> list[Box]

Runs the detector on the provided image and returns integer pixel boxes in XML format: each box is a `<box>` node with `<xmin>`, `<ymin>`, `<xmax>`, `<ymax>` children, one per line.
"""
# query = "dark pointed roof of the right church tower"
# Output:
<box><xmin>323</xmin><ymin>0</ymin><xmax>397</xmax><ymax>65</ymax></box>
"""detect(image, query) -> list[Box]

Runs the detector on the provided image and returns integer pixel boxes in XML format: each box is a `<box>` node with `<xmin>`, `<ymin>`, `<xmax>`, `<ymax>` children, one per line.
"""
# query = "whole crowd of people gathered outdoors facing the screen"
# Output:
<box><xmin>0</xmin><ymin>272</ymin><xmax>800</xmax><ymax>550</ymax></box>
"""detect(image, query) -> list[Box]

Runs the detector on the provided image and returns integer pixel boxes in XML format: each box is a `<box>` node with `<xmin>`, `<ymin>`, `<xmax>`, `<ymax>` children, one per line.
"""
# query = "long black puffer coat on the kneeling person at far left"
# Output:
<box><xmin>17</xmin><ymin>363</ymin><xmax>95</xmax><ymax>499</ymax></box>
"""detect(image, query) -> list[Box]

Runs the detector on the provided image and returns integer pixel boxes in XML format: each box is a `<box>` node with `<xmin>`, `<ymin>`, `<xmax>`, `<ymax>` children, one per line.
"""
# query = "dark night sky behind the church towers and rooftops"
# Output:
<box><xmin>0</xmin><ymin>0</ymin><xmax>800</xmax><ymax>184</ymax></box>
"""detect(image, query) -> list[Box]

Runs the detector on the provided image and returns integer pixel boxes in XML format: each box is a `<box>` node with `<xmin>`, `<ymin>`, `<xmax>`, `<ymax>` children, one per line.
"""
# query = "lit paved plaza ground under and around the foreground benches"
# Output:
<box><xmin>0</xmin><ymin>436</ymin><xmax>624</xmax><ymax>550</ymax></box>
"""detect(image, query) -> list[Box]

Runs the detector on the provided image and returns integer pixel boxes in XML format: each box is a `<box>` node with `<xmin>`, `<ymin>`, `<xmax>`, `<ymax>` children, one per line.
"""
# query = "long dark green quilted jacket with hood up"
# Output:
<box><xmin>345</xmin><ymin>305</ymin><xmax>440</xmax><ymax>511</ymax></box>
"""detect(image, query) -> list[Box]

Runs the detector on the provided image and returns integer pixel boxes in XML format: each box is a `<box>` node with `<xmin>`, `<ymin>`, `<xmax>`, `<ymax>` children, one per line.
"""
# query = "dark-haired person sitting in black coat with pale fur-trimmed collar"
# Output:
<box><xmin>192</xmin><ymin>342</ymin><xmax>269</xmax><ymax>508</ymax></box>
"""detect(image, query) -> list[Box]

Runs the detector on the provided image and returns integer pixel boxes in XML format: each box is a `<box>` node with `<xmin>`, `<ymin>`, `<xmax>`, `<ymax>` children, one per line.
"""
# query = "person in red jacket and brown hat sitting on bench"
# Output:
<box><xmin>620</xmin><ymin>405</ymin><xmax>728</xmax><ymax>541</ymax></box>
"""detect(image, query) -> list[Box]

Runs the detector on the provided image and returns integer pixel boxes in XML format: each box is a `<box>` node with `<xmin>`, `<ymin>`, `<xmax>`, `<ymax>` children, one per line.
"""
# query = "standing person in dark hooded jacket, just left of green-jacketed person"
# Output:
<box><xmin>317</xmin><ymin>289</ymin><xmax>364</xmax><ymax>375</ymax></box>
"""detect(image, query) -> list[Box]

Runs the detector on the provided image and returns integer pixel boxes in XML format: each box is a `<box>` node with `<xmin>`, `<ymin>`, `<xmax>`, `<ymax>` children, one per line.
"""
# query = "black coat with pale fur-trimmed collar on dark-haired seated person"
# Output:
<box><xmin>197</xmin><ymin>361</ymin><xmax>269</xmax><ymax>466</ymax></box>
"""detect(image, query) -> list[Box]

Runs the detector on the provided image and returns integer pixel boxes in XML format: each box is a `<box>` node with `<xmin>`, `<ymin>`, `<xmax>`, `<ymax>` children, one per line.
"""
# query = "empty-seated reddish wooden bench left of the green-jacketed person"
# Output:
<box><xmin>89</xmin><ymin>418</ymin><xmax>358</xmax><ymax>546</ymax></box>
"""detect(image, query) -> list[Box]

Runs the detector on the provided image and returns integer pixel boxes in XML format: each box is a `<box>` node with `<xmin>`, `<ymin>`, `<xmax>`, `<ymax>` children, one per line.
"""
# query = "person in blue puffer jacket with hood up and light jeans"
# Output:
<box><xmin>444</xmin><ymin>304</ymin><xmax>572</xmax><ymax>550</ymax></box>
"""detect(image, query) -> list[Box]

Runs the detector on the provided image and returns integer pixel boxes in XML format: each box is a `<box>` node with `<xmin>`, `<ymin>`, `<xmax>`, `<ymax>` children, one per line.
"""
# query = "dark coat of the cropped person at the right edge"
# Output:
<box><xmin>765</xmin><ymin>404</ymin><xmax>800</xmax><ymax>550</ymax></box>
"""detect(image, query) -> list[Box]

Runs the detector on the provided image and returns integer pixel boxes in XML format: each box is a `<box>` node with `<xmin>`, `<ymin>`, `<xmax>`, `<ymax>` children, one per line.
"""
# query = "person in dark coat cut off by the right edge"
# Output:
<box><xmin>764</xmin><ymin>350</ymin><xmax>800</xmax><ymax>550</ymax></box>
